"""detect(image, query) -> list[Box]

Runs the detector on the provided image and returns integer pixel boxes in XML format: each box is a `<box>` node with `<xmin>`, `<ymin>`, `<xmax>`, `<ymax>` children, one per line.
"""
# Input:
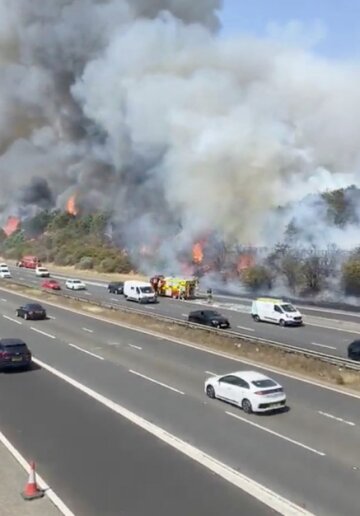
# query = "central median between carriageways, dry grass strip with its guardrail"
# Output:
<box><xmin>1</xmin><ymin>281</ymin><xmax>360</xmax><ymax>392</ymax></box>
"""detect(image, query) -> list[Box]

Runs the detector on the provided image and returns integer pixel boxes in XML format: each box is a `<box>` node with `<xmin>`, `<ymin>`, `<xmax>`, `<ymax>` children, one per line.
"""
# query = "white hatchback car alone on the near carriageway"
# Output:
<box><xmin>205</xmin><ymin>371</ymin><xmax>286</xmax><ymax>414</ymax></box>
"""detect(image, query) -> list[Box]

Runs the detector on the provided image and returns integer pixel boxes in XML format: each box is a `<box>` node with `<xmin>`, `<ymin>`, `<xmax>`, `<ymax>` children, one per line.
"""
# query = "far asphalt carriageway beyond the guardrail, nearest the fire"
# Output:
<box><xmin>3</xmin><ymin>267</ymin><xmax>360</xmax><ymax>358</ymax></box>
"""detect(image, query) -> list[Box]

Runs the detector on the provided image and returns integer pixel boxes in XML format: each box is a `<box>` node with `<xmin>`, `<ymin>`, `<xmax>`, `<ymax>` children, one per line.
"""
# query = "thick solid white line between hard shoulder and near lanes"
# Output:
<box><xmin>33</xmin><ymin>358</ymin><xmax>314</xmax><ymax>516</ymax></box>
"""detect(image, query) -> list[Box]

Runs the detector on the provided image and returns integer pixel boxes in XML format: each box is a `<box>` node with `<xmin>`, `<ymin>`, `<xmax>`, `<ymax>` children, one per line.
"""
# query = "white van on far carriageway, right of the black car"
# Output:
<box><xmin>251</xmin><ymin>297</ymin><xmax>303</xmax><ymax>326</ymax></box>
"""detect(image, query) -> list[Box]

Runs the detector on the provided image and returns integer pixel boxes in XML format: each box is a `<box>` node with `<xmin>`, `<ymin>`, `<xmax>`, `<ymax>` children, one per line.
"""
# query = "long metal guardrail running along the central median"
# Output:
<box><xmin>7</xmin><ymin>279</ymin><xmax>360</xmax><ymax>371</ymax></box>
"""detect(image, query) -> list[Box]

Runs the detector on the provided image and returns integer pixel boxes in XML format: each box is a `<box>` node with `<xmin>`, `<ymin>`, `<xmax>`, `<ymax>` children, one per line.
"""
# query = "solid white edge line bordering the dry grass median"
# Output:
<box><xmin>0</xmin><ymin>287</ymin><xmax>360</xmax><ymax>399</ymax></box>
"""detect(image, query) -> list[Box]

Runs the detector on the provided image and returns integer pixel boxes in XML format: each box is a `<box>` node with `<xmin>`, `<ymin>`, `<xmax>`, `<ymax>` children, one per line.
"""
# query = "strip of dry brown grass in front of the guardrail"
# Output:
<box><xmin>7</xmin><ymin>283</ymin><xmax>360</xmax><ymax>391</ymax></box>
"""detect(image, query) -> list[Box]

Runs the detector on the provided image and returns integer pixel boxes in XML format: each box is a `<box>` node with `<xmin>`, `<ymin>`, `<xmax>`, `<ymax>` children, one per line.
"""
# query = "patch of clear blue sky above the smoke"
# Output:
<box><xmin>220</xmin><ymin>0</ymin><xmax>360</xmax><ymax>60</ymax></box>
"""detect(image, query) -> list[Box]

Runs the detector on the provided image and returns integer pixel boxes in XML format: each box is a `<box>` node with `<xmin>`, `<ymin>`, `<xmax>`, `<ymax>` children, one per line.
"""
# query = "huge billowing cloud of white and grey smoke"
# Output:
<box><xmin>0</xmin><ymin>0</ymin><xmax>360</xmax><ymax>259</ymax></box>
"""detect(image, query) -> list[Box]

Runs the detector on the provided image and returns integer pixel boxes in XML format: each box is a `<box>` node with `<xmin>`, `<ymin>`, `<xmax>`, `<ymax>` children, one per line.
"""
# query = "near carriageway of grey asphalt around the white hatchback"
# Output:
<box><xmin>0</xmin><ymin>284</ymin><xmax>360</xmax><ymax>516</ymax></box>
